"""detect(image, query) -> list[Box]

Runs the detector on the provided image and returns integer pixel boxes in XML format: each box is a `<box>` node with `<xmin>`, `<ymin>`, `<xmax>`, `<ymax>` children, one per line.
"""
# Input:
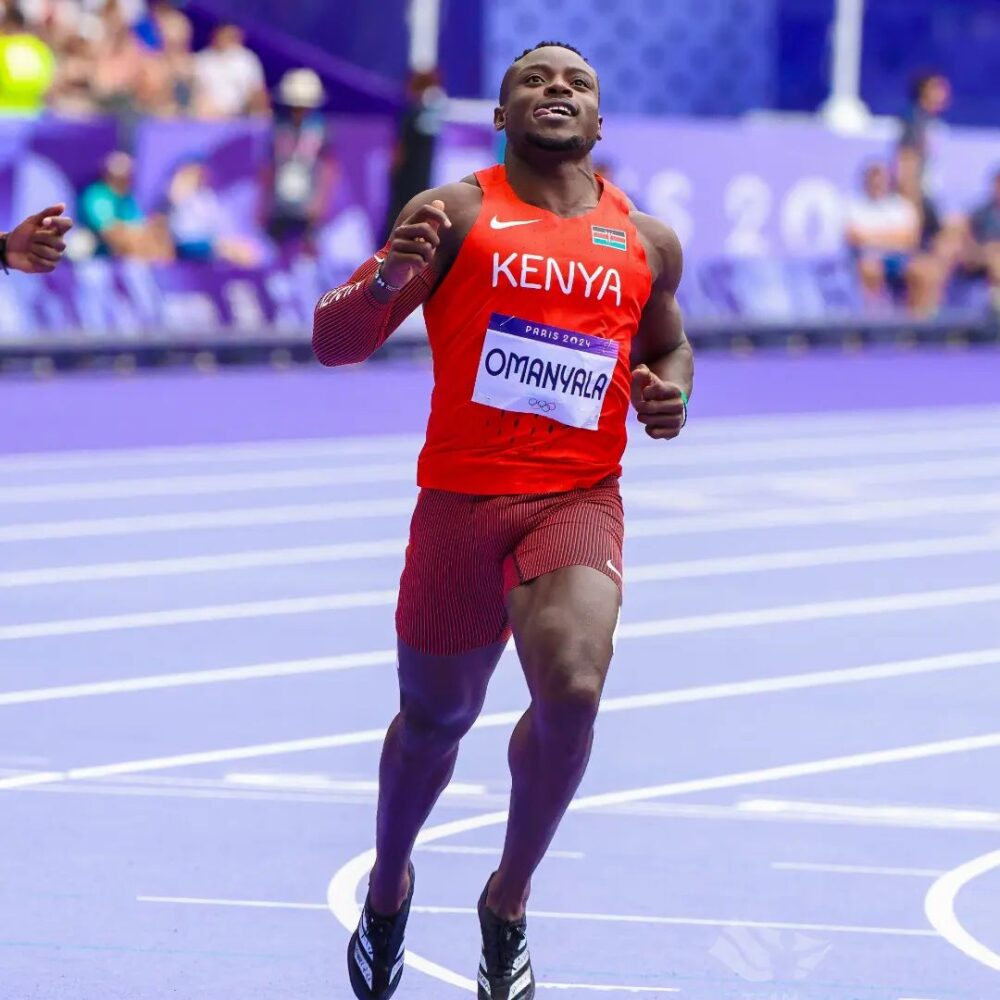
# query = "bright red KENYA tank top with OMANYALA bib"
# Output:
<box><xmin>417</xmin><ymin>165</ymin><xmax>652</xmax><ymax>494</ymax></box>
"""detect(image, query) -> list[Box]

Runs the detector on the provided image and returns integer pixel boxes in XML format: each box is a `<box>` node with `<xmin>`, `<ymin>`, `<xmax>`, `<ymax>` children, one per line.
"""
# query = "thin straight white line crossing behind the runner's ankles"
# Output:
<box><xmin>136</xmin><ymin>896</ymin><xmax>938</xmax><ymax>937</ymax></box>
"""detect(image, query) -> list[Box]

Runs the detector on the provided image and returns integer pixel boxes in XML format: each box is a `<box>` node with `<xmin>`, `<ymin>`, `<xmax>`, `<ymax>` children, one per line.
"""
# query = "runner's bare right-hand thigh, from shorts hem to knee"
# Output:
<box><xmin>507</xmin><ymin>565</ymin><xmax>621</xmax><ymax>699</ymax></box>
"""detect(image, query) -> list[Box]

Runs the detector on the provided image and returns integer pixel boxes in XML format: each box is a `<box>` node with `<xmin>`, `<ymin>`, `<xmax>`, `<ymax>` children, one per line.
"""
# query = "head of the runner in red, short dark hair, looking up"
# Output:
<box><xmin>494</xmin><ymin>46</ymin><xmax>602</xmax><ymax>153</ymax></box>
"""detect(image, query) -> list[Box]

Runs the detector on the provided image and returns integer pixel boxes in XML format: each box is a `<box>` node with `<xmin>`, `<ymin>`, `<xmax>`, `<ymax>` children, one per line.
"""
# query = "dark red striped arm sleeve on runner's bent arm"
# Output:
<box><xmin>313</xmin><ymin>243</ymin><xmax>434</xmax><ymax>367</ymax></box>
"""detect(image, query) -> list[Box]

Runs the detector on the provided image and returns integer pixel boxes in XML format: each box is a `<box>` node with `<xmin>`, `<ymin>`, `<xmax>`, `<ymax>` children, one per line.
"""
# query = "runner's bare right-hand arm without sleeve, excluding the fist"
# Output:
<box><xmin>632</xmin><ymin>213</ymin><xmax>694</xmax><ymax>397</ymax></box>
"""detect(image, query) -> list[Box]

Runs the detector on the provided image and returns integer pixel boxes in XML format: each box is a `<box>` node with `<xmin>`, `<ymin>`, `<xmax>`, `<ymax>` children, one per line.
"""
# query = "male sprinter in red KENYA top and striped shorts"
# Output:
<box><xmin>313</xmin><ymin>42</ymin><xmax>692</xmax><ymax>1000</ymax></box>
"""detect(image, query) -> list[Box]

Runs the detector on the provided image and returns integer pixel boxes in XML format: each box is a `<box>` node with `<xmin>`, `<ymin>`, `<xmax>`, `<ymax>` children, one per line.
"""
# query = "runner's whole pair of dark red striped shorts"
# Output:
<box><xmin>396</xmin><ymin>476</ymin><xmax>625</xmax><ymax>656</ymax></box>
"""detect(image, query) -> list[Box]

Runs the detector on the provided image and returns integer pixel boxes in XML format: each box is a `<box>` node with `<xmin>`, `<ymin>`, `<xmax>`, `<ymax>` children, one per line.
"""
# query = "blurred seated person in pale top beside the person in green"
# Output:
<box><xmin>167</xmin><ymin>160</ymin><xmax>260</xmax><ymax>267</ymax></box>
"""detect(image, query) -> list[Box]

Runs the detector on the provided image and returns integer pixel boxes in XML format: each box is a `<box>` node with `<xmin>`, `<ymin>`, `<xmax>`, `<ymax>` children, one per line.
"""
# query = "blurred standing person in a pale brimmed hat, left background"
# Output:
<box><xmin>262</xmin><ymin>69</ymin><xmax>337</xmax><ymax>254</ymax></box>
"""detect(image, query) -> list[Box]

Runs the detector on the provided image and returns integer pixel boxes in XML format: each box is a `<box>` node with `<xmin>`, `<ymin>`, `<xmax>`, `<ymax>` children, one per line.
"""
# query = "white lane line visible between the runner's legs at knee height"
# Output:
<box><xmin>7</xmin><ymin>653</ymin><xmax>1000</xmax><ymax>789</ymax></box>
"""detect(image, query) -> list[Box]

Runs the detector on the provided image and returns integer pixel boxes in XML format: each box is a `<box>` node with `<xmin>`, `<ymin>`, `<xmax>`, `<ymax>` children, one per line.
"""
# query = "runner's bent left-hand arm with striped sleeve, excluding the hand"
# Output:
<box><xmin>312</xmin><ymin>181</ymin><xmax>482</xmax><ymax>366</ymax></box>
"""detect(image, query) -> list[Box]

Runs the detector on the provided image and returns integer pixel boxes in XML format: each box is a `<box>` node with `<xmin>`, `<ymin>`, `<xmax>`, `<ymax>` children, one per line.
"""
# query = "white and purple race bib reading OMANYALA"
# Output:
<box><xmin>472</xmin><ymin>313</ymin><xmax>618</xmax><ymax>431</ymax></box>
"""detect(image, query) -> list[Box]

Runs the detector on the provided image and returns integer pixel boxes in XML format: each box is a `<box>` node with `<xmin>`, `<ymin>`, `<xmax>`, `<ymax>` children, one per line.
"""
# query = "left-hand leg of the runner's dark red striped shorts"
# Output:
<box><xmin>396</xmin><ymin>490</ymin><xmax>510</xmax><ymax>656</ymax></box>
